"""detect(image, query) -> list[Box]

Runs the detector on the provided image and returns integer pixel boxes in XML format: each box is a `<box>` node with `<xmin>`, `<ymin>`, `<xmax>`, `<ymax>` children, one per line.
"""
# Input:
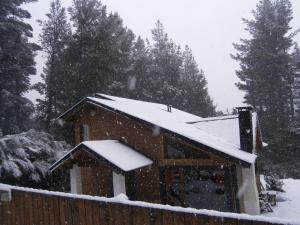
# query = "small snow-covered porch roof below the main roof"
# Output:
<box><xmin>50</xmin><ymin>140</ymin><xmax>153</xmax><ymax>172</ymax></box>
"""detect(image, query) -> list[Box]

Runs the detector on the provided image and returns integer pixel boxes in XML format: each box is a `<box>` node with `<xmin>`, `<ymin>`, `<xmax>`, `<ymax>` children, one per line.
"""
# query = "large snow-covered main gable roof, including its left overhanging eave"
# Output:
<box><xmin>59</xmin><ymin>94</ymin><xmax>256</xmax><ymax>166</ymax></box>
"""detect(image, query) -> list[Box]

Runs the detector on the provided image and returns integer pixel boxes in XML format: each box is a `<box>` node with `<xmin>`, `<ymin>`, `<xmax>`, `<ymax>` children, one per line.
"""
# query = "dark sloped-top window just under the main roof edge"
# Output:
<box><xmin>165</xmin><ymin>139</ymin><xmax>209</xmax><ymax>159</ymax></box>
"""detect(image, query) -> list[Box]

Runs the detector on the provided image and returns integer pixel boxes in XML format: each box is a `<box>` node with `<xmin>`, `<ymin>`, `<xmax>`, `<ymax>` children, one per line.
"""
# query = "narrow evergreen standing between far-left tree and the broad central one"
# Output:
<box><xmin>36</xmin><ymin>0</ymin><xmax>71</xmax><ymax>130</ymax></box>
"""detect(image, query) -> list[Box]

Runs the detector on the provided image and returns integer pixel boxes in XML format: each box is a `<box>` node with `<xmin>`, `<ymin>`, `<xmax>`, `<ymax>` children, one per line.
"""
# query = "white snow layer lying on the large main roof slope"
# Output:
<box><xmin>83</xmin><ymin>94</ymin><xmax>256</xmax><ymax>164</ymax></box>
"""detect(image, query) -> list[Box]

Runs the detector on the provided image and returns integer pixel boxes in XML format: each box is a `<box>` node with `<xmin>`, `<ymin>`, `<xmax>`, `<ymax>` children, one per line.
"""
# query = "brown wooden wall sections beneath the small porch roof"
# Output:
<box><xmin>81</xmin><ymin>163</ymin><xmax>160</xmax><ymax>203</ymax></box>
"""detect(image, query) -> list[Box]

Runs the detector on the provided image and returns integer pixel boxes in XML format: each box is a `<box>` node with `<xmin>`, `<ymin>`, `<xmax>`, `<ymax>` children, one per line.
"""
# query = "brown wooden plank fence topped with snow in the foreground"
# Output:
<box><xmin>0</xmin><ymin>185</ymin><xmax>292</xmax><ymax>225</ymax></box>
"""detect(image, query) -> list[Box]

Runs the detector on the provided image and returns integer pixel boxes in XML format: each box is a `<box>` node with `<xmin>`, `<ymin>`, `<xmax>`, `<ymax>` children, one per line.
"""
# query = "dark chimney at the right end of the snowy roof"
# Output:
<box><xmin>236</xmin><ymin>107</ymin><xmax>253</xmax><ymax>153</ymax></box>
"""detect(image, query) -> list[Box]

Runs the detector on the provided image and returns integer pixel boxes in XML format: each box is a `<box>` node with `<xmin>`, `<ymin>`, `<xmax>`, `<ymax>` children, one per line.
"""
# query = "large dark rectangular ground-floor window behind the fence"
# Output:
<box><xmin>164</xmin><ymin>167</ymin><xmax>232</xmax><ymax>211</ymax></box>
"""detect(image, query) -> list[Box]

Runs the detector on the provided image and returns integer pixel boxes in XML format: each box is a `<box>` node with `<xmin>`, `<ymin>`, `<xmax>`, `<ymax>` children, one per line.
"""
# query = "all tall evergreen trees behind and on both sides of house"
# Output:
<box><xmin>0</xmin><ymin>0</ymin><xmax>300</xmax><ymax>181</ymax></box>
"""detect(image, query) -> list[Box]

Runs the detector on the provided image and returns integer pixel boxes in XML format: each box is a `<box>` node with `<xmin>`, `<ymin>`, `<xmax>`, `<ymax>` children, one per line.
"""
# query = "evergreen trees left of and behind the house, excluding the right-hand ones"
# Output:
<box><xmin>0</xmin><ymin>0</ymin><xmax>215</xmax><ymax>139</ymax></box>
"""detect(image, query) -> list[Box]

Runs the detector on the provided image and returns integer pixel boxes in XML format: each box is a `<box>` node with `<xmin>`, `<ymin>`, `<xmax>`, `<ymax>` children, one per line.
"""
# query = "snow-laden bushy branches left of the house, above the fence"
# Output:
<box><xmin>0</xmin><ymin>129</ymin><xmax>70</xmax><ymax>186</ymax></box>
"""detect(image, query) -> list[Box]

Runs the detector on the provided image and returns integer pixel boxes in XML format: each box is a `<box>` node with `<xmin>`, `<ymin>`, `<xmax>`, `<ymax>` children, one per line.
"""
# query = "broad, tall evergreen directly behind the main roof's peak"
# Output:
<box><xmin>60</xmin><ymin>0</ymin><xmax>134</xmax><ymax>110</ymax></box>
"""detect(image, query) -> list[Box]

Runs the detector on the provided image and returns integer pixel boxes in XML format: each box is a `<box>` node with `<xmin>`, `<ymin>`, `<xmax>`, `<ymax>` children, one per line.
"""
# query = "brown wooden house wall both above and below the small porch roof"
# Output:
<box><xmin>74</xmin><ymin>106</ymin><xmax>164</xmax><ymax>203</ymax></box>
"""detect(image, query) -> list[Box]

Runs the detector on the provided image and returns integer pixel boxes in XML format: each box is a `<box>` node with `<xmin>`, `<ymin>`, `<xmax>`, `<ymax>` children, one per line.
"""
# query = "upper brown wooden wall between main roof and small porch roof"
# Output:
<box><xmin>74</xmin><ymin>105</ymin><xmax>164</xmax><ymax>161</ymax></box>
